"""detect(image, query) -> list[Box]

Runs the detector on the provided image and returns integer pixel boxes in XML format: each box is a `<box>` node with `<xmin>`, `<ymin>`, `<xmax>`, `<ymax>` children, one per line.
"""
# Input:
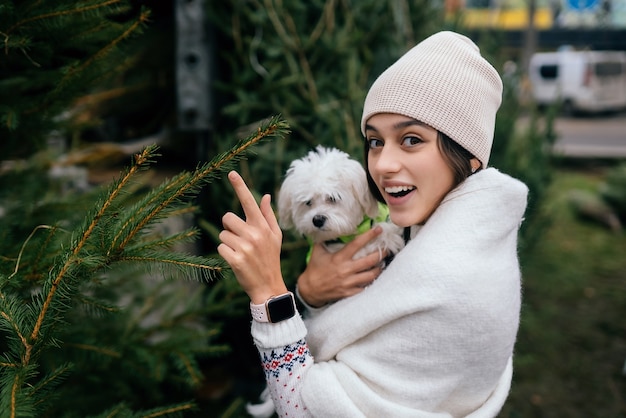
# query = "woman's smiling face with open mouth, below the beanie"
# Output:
<box><xmin>365</xmin><ymin>113</ymin><xmax>455</xmax><ymax>227</ymax></box>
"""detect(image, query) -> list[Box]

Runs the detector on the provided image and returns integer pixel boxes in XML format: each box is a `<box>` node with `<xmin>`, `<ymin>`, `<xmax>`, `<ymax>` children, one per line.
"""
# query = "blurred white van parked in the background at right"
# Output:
<box><xmin>528</xmin><ymin>50</ymin><xmax>626</xmax><ymax>114</ymax></box>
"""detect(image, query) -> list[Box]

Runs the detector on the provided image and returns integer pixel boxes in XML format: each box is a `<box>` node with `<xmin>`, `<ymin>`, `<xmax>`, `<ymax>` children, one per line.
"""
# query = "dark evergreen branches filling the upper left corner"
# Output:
<box><xmin>0</xmin><ymin>0</ymin><xmax>155</xmax><ymax>158</ymax></box>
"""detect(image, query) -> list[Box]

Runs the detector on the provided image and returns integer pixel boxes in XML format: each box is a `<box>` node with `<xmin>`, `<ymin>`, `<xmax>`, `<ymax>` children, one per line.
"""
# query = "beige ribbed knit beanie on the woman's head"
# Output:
<box><xmin>361</xmin><ymin>31</ymin><xmax>502</xmax><ymax>167</ymax></box>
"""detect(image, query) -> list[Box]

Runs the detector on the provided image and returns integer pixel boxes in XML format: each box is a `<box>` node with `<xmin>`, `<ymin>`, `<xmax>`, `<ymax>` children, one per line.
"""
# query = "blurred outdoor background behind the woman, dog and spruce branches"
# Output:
<box><xmin>0</xmin><ymin>0</ymin><xmax>626</xmax><ymax>418</ymax></box>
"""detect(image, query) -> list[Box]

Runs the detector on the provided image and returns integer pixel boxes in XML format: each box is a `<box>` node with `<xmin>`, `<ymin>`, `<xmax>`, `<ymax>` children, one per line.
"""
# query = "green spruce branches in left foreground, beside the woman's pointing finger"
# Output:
<box><xmin>0</xmin><ymin>117</ymin><xmax>288</xmax><ymax>418</ymax></box>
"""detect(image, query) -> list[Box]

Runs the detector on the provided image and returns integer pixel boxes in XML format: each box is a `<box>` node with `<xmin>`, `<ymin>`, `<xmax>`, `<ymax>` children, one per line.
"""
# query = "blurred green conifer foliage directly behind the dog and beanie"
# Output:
<box><xmin>208</xmin><ymin>0</ymin><xmax>442</xmax><ymax>155</ymax></box>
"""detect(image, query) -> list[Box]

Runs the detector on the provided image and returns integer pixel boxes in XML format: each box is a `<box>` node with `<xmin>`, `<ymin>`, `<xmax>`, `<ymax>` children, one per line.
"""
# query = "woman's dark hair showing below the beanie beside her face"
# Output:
<box><xmin>363</xmin><ymin>131</ymin><xmax>480</xmax><ymax>203</ymax></box>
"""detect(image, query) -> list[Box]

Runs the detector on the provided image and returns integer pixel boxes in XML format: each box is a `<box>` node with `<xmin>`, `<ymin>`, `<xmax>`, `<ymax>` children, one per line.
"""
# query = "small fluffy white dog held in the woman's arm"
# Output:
<box><xmin>246</xmin><ymin>146</ymin><xmax>404</xmax><ymax>418</ymax></box>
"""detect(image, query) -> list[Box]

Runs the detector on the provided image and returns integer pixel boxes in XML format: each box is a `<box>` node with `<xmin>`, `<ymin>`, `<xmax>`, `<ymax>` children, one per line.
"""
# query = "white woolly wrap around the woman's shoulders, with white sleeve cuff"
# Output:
<box><xmin>252</xmin><ymin>168</ymin><xmax>527</xmax><ymax>418</ymax></box>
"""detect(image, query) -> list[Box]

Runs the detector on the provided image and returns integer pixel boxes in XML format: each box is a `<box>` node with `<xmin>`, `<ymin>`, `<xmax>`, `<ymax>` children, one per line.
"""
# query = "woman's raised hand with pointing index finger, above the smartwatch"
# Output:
<box><xmin>217</xmin><ymin>171</ymin><xmax>287</xmax><ymax>304</ymax></box>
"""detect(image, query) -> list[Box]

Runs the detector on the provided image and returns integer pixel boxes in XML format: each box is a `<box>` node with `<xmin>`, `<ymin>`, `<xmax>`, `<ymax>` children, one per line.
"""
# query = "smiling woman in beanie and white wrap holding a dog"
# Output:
<box><xmin>218</xmin><ymin>32</ymin><xmax>527</xmax><ymax>417</ymax></box>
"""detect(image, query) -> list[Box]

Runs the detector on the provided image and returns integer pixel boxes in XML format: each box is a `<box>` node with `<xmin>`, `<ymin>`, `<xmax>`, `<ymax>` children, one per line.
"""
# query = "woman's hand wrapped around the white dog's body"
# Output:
<box><xmin>298</xmin><ymin>227</ymin><xmax>387</xmax><ymax>307</ymax></box>
